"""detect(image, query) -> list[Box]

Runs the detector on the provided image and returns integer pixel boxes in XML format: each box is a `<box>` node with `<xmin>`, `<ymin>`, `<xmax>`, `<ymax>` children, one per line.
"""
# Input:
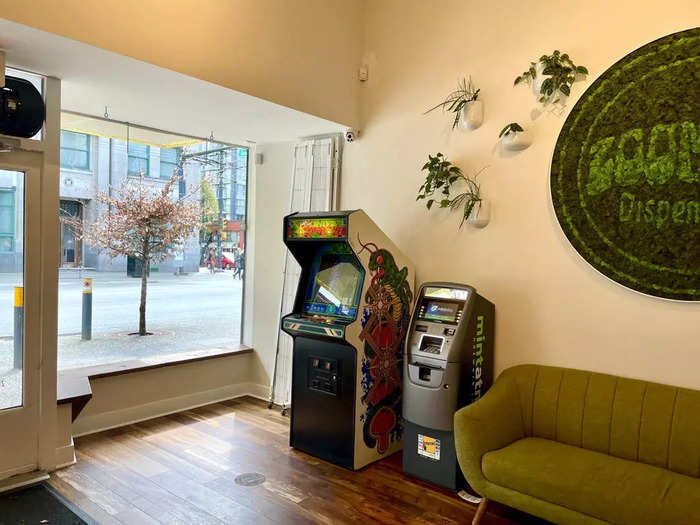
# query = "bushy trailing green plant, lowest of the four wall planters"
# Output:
<box><xmin>416</xmin><ymin>153</ymin><xmax>483</xmax><ymax>228</ymax></box>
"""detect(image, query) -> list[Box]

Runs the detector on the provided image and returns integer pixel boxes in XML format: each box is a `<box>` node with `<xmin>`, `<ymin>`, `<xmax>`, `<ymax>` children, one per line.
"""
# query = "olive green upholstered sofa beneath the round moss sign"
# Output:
<box><xmin>455</xmin><ymin>365</ymin><xmax>700</xmax><ymax>525</ymax></box>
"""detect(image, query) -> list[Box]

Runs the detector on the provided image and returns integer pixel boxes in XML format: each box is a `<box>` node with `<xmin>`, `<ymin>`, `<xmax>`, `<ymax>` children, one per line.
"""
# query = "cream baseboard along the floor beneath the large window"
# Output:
<box><xmin>73</xmin><ymin>383</ymin><xmax>268</xmax><ymax>438</ymax></box>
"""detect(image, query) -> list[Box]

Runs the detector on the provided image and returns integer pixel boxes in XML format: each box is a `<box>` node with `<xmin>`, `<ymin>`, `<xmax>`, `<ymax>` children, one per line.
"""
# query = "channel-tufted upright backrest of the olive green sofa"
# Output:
<box><xmin>499</xmin><ymin>365</ymin><xmax>700</xmax><ymax>477</ymax></box>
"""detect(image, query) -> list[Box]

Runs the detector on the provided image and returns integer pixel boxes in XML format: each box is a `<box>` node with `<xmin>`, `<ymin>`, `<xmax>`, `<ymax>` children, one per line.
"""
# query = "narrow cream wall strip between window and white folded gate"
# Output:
<box><xmin>253</xmin><ymin>142</ymin><xmax>294</xmax><ymax>383</ymax></box>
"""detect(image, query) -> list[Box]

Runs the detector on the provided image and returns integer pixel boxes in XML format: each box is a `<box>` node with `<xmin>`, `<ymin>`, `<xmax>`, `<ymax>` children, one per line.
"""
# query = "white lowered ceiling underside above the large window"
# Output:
<box><xmin>0</xmin><ymin>18</ymin><xmax>344</xmax><ymax>145</ymax></box>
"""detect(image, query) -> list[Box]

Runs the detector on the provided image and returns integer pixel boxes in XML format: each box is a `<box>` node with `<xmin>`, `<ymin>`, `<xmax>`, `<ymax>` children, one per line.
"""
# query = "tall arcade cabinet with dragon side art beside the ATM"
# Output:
<box><xmin>281</xmin><ymin>210</ymin><xmax>414</xmax><ymax>470</ymax></box>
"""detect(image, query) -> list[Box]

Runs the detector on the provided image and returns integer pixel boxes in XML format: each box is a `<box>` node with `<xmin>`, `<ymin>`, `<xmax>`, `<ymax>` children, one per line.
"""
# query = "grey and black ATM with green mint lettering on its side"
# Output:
<box><xmin>403</xmin><ymin>283</ymin><xmax>495</xmax><ymax>490</ymax></box>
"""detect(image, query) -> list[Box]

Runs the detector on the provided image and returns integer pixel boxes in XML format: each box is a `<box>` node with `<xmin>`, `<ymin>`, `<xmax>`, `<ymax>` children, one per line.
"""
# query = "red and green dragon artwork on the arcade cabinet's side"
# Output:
<box><xmin>359</xmin><ymin>237</ymin><xmax>413</xmax><ymax>454</ymax></box>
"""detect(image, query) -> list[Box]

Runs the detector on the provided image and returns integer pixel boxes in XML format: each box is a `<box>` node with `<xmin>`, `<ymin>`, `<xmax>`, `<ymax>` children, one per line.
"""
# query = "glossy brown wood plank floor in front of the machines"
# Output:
<box><xmin>50</xmin><ymin>398</ymin><xmax>534</xmax><ymax>525</ymax></box>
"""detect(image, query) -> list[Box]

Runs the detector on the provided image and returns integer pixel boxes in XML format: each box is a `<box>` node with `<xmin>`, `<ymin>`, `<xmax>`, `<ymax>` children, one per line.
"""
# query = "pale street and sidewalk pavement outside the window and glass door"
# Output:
<box><xmin>0</xmin><ymin>271</ymin><xmax>243</xmax><ymax>408</ymax></box>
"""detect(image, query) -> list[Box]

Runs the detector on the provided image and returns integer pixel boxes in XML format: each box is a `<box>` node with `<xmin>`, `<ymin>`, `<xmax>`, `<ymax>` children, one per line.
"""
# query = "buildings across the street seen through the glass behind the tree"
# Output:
<box><xmin>58</xmin><ymin>129</ymin><xmax>248</xmax><ymax>272</ymax></box>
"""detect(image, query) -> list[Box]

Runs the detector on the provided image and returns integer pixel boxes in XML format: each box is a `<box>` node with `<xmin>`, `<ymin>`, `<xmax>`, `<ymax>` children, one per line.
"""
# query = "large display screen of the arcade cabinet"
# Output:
<box><xmin>304</xmin><ymin>253</ymin><xmax>363</xmax><ymax>319</ymax></box>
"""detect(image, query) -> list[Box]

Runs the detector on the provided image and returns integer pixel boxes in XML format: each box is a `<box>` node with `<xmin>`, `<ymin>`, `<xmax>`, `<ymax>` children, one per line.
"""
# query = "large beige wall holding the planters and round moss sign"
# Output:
<box><xmin>342</xmin><ymin>0</ymin><xmax>700</xmax><ymax>388</ymax></box>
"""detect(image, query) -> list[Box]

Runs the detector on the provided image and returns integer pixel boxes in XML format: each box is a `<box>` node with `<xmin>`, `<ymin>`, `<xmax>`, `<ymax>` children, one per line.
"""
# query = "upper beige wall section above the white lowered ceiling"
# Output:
<box><xmin>0</xmin><ymin>0</ymin><xmax>364</xmax><ymax>125</ymax></box>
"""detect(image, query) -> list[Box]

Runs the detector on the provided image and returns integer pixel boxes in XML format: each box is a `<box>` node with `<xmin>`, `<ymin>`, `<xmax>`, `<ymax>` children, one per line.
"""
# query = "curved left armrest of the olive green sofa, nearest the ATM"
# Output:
<box><xmin>454</xmin><ymin>376</ymin><xmax>525</xmax><ymax>496</ymax></box>
